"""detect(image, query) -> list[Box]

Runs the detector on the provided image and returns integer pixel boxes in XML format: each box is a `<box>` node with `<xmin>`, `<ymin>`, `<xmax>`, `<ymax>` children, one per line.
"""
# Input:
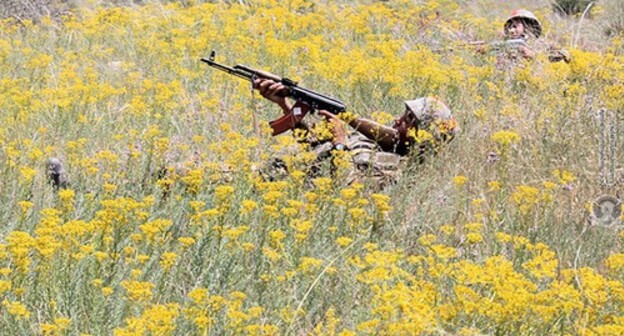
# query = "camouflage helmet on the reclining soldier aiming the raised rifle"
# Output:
<box><xmin>405</xmin><ymin>97</ymin><xmax>457</xmax><ymax>141</ymax></box>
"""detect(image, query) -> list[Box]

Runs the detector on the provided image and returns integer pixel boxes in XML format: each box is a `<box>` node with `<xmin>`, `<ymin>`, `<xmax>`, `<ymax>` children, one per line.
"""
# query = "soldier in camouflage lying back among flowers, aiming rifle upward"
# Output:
<box><xmin>254</xmin><ymin>78</ymin><xmax>456</xmax><ymax>188</ymax></box>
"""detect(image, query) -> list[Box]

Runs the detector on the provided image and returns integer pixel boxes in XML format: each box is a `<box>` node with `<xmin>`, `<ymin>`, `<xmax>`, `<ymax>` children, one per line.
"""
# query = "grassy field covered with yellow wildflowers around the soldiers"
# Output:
<box><xmin>0</xmin><ymin>0</ymin><xmax>624</xmax><ymax>335</ymax></box>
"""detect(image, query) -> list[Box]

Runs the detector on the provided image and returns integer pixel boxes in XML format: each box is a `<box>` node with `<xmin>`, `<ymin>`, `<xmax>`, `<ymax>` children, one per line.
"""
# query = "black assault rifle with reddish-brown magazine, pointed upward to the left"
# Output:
<box><xmin>201</xmin><ymin>50</ymin><xmax>346</xmax><ymax>136</ymax></box>
